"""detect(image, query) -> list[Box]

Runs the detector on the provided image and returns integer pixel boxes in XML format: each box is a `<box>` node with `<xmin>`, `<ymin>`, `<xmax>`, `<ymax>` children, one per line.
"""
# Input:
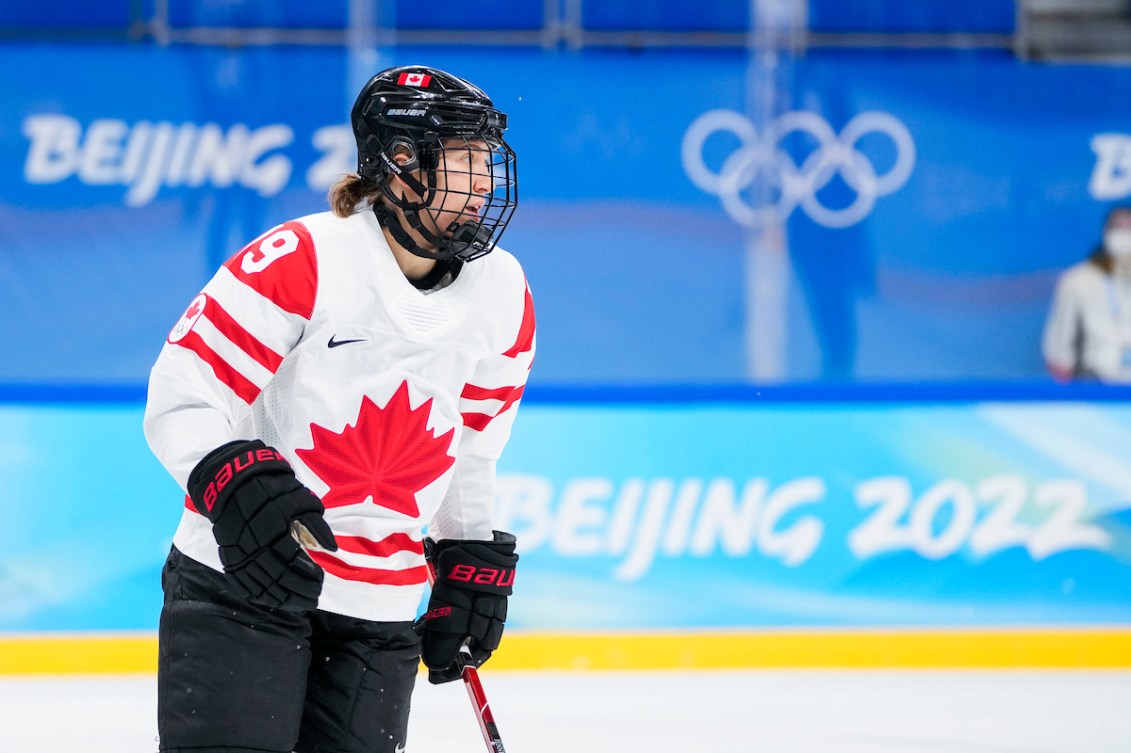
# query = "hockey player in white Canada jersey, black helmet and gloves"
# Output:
<box><xmin>145</xmin><ymin>66</ymin><xmax>535</xmax><ymax>753</ymax></box>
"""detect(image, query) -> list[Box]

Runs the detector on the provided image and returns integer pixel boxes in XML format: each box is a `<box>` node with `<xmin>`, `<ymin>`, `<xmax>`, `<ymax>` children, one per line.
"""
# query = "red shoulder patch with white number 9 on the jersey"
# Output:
<box><xmin>224</xmin><ymin>220</ymin><xmax>318</xmax><ymax>319</ymax></box>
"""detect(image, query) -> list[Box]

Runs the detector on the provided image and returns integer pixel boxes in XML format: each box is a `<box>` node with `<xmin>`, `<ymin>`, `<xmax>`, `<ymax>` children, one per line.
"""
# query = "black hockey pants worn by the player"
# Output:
<box><xmin>157</xmin><ymin>547</ymin><xmax>420</xmax><ymax>753</ymax></box>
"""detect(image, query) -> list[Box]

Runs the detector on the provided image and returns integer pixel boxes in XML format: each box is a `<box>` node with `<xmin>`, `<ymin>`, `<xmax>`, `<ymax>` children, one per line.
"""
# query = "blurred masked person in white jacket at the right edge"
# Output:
<box><xmin>1042</xmin><ymin>207</ymin><xmax>1131</xmax><ymax>384</ymax></box>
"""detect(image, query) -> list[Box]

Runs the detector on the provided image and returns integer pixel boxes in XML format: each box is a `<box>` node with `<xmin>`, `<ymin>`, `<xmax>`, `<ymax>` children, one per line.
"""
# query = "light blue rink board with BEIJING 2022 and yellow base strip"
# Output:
<box><xmin>0</xmin><ymin>401</ymin><xmax>1131</xmax><ymax>673</ymax></box>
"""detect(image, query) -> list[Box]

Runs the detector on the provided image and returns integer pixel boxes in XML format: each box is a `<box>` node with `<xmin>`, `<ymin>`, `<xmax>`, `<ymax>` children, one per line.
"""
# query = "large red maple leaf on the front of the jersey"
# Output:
<box><xmin>296</xmin><ymin>382</ymin><xmax>456</xmax><ymax>518</ymax></box>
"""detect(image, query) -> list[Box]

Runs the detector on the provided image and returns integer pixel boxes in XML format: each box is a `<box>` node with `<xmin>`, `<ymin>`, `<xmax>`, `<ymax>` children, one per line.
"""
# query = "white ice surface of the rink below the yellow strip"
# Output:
<box><xmin>0</xmin><ymin>667</ymin><xmax>1131</xmax><ymax>753</ymax></box>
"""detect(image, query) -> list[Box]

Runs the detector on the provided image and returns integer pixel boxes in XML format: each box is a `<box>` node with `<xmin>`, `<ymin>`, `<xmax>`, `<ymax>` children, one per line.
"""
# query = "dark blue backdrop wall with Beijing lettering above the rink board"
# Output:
<box><xmin>8</xmin><ymin>43</ymin><xmax>1131</xmax><ymax>384</ymax></box>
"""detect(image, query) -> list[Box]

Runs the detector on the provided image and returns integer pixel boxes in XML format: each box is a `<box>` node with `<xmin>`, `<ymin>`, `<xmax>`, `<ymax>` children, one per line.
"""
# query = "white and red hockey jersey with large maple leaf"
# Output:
<box><xmin>145</xmin><ymin>211</ymin><xmax>535</xmax><ymax>621</ymax></box>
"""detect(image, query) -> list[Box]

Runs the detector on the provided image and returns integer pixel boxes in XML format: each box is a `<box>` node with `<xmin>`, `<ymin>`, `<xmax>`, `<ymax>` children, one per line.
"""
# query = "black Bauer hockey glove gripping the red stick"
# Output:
<box><xmin>416</xmin><ymin>530</ymin><xmax>518</xmax><ymax>685</ymax></box>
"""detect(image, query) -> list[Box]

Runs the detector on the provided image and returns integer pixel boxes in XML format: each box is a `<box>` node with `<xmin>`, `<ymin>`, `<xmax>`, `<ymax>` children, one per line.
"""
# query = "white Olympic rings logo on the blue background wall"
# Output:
<box><xmin>682</xmin><ymin>110</ymin><xmax>915</xmax><ymax>227</ymax></box>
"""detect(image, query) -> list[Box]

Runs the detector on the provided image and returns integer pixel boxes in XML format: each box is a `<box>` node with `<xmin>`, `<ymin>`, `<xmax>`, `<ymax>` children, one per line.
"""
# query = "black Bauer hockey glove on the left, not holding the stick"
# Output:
<box><xmin>189</xmin><ymin>440</ymin><xmax>338</xmax><ymax>612</ymax></box>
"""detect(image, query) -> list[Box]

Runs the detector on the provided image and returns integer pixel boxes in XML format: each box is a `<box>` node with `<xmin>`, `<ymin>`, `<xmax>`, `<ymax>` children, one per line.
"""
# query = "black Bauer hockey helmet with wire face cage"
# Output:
<box><xmin>349</xmin><ymin>66</ymin><xmax>518</xmax><ymax>261</ymax></box>
